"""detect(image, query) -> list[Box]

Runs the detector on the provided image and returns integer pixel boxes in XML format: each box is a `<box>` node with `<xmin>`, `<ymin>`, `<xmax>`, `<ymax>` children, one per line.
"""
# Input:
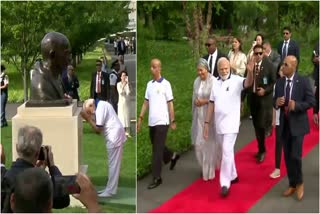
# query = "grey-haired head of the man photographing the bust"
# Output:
<box><xmin>16</xmin><ymin>126</ymin><xmax>42</xmax><ymax>161</ymax></box>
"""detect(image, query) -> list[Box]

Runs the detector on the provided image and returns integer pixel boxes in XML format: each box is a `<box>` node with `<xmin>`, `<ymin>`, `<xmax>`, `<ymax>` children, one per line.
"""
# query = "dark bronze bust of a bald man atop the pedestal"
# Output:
<box><xmin>30</xmin><ymin>32</ymin><xmax>71</xmax><ymax>101</ymax></box>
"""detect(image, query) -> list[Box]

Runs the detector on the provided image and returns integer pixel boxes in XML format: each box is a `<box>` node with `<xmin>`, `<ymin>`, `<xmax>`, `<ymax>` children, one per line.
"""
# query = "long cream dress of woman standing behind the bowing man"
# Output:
<box><xmin>117</xmin><ymin>82</ymin><xmax>130</xmax><ymax>128</ymax></box>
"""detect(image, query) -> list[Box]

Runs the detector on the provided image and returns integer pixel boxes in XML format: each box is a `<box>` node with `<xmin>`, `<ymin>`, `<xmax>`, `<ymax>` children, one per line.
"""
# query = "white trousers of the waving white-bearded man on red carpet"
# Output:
<box><xmin>216</xmin><ymin>133</ymin><xmax>238</xmax><ymax>188</ymax></box>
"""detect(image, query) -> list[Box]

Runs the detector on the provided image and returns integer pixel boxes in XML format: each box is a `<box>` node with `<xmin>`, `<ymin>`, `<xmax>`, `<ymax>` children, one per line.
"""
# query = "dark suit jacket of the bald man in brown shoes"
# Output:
<box><xmin>273</xmin><ymin>73</ymin><xmax>315</xmax><ymax>136</ymax></box>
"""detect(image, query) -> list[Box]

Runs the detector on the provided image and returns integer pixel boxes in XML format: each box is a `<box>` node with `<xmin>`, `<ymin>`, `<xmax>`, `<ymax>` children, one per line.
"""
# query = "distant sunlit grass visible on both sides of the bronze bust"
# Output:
<box><xmin>2</xmin><ymin>41</ymin><xmax>111</xmax><ymax>102</ymax></box>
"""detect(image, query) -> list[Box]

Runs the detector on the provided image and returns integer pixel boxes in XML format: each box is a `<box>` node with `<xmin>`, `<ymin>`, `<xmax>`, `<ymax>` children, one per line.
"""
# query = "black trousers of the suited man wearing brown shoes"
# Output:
<box><xmin>282</xmin><ymin>119</ymin><xmax>304</xmax><ymax>188</ymax></box>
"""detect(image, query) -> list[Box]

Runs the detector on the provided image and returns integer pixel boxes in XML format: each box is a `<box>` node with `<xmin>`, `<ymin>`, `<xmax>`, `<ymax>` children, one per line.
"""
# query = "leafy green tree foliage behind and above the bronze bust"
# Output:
<box><xmin>1</xmin><ymin>1</ymin><xmax>130</xmax><ymax>100</ymax></box>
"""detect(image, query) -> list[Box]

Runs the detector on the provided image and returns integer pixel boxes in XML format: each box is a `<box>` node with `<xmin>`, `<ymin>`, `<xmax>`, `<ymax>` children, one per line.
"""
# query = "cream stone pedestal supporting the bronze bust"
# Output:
<box><xmin>12</xmin><ymin>100</ymin><xmax>83</xmax><ymax>175</ymax></box>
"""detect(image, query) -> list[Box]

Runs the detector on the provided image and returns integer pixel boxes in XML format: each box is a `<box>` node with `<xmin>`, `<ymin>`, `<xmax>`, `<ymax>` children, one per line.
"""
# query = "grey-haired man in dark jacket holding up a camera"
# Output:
<box><xmin>1</xmin><ymin>126</ymin><xmax>70</xmax><ymax>212</ymax></box>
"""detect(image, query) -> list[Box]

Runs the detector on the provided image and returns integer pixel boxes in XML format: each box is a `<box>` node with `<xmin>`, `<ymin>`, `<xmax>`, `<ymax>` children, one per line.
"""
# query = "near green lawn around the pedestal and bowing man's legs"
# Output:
<box><xmin>1</xmin><ymin>122</ymin><xmax>136</xmax><ymax>213</ymax></box>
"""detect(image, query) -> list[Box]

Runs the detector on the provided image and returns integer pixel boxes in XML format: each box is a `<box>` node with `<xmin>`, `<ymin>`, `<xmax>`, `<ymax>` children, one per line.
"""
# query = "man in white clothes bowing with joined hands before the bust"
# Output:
<box><xmin>81</xmin><ymin>99</ymin><xmax>127</xmax><ymax>197</ymax></box>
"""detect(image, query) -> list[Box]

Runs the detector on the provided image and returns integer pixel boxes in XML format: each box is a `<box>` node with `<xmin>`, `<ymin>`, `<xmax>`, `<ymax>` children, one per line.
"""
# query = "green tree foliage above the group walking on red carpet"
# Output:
<box><xmin>138</xmin><ymin>1</ymin><xmax>319</xmax><ymax>57</ymax></box>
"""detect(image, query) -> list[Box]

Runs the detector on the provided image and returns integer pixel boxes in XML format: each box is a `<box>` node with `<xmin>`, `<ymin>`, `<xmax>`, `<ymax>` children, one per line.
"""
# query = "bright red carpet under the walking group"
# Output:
<box><xmin>150</xmin><ymin>110</ymin><xmax>319</xmax><ymax>213</ymax></box>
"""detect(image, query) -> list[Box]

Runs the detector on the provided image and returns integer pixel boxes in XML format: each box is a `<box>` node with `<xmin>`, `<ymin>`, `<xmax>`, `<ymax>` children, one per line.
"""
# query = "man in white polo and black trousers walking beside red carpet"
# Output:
<box><xmin>137</xmin><ymin>59</ymin><xmax>180</xmax><ymax>189</ymax></box>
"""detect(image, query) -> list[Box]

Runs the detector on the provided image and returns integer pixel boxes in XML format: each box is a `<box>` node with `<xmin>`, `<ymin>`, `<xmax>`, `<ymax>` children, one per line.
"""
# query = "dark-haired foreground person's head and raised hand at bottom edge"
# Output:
<box><xmin>10</xmin><ymin>167</ymin><xmax>101</xmax><ymax>213</ymax></box>
